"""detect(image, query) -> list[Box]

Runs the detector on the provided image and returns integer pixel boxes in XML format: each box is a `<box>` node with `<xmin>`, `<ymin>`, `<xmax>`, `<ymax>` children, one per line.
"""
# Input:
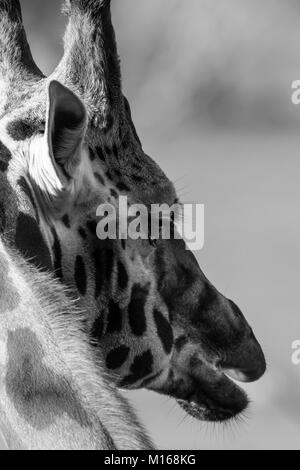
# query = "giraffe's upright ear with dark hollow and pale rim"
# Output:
<box><xmin>46</xmin><ymin>81</ymin><xmax>87</xmax><ymax>180</ymax></box>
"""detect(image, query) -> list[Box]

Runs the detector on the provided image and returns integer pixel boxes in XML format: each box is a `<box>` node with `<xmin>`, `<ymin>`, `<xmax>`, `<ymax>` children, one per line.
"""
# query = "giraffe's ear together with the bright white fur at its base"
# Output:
<box><xmin>29</xmin><ymin>81</ymin><xmax>87</xmax><ymax>209</ymax></box>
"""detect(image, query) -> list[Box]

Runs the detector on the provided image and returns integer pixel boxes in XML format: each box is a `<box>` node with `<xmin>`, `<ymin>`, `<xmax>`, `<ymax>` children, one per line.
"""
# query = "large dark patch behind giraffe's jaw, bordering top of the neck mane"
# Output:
<box><xmin>15</xmin><ymin>212</ymin><xmax>52</xmax><ymax>271</ymax></box>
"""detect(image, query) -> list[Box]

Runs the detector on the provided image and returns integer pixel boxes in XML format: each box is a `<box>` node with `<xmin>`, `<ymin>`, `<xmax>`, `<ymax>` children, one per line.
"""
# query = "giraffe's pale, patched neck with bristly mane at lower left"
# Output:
<box><xmin>0</xmin><ymin>241</ymin><xmax>151</xmax><ymax>449</ymax></box>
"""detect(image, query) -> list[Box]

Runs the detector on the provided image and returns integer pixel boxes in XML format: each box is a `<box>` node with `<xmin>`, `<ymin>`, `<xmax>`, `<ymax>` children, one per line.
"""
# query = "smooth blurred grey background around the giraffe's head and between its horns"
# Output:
<box><xmin>9</xmin><ymin>0</ymin><xmax>300</xmax><ymax>449</ymax></box>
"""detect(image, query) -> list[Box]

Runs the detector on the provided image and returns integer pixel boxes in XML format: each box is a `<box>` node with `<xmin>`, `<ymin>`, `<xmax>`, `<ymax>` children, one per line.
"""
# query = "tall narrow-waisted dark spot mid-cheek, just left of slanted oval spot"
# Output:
<box><xmin>128</xmin><ymin>284</ymin><xmax>148</xmax><ymax>336</ymax></box>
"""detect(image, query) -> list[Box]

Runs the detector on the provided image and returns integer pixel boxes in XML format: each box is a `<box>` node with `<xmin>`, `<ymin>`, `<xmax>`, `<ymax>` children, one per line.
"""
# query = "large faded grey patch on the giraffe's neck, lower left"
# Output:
<box><xmin>5</xmin><ymin>328</ymin><xmax>92</xmax><ymax>430</ymax></box>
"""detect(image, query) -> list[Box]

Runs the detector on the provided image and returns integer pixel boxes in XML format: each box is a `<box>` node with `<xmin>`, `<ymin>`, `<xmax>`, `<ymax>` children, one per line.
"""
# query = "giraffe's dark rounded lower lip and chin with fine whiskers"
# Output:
<box><xmin>177</xmin><ymin>368</ymin><xmax>249</xmax><ymax>422</ymax></box>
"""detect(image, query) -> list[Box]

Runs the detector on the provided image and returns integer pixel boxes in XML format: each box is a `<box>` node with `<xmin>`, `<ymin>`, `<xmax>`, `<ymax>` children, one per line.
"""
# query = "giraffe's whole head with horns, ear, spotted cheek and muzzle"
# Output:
<box><xmin>0</xmin><ymin>0</ymin><xmax>265</xmax><ymax>421</ymax></box>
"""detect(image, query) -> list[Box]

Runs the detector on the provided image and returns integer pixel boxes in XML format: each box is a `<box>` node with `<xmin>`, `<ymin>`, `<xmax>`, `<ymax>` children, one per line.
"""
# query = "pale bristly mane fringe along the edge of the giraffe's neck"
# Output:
<box><xmin>4</xmin><ymin>243</ymin><xmax>153</xmax><ymax>450</ymax></box>
